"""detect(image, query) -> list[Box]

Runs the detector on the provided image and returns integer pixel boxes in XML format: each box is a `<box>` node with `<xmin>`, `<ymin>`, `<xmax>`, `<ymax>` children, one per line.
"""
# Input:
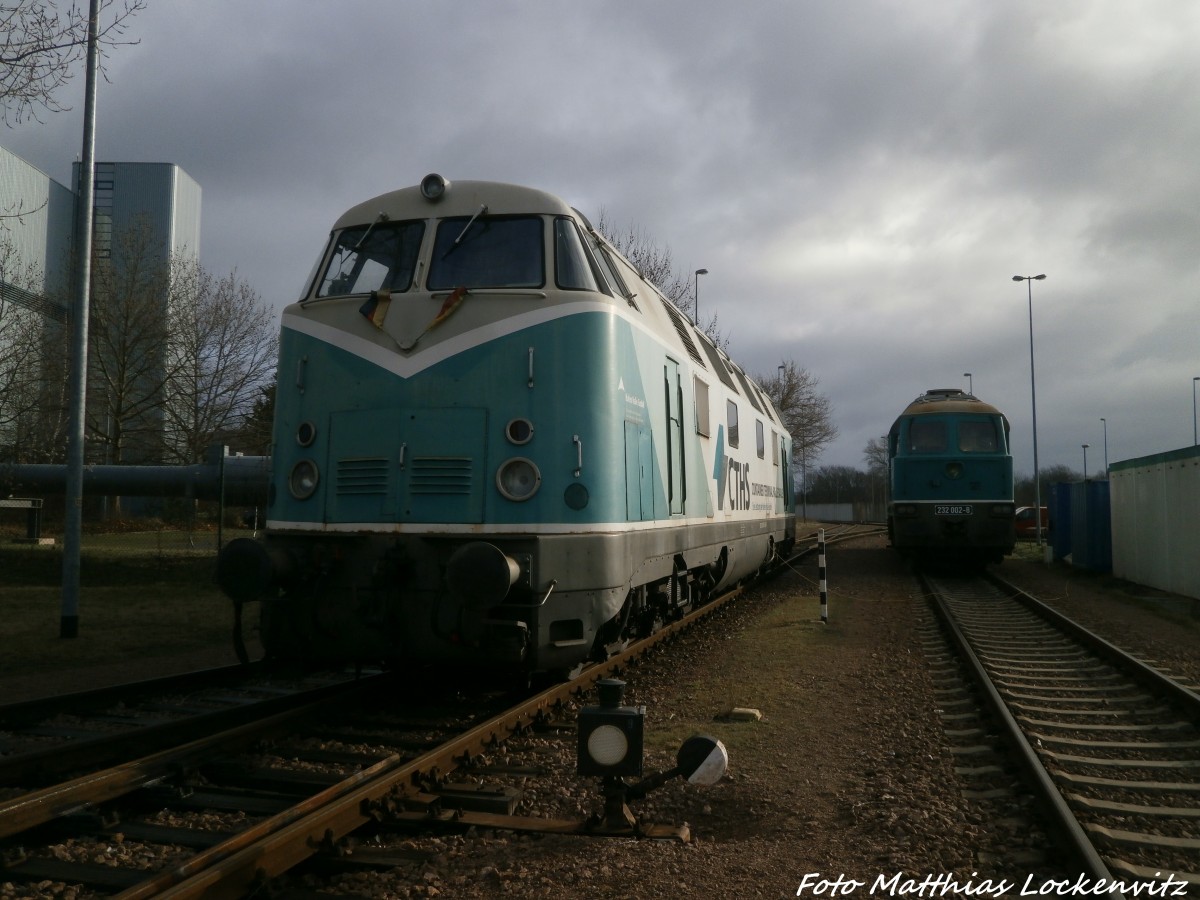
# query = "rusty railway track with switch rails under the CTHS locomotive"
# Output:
<box><xmin>0</xmin><ymin>527</ymin><xmax>872</xmax><ymax>899</ymax></box>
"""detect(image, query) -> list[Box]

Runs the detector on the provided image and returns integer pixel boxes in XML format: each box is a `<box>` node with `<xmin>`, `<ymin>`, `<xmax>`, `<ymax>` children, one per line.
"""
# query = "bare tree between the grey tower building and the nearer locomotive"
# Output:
<box><xmin>164</xmin><ymin>256</ymin><xmax>277</xmax><ymax>463</ymax></box>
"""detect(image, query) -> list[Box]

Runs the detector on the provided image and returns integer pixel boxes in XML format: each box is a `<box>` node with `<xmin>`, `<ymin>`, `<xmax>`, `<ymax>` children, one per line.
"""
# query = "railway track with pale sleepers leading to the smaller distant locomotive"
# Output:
<box><xmin>922</xmin><ymin>575</ymin><xmax>1200</xmax><ymax>887</ymax></box>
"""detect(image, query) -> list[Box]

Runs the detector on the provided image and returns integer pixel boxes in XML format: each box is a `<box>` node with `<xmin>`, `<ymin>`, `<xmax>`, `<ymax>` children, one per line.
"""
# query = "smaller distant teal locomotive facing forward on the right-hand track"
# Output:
<box><xmin>888</xmin><ymin>388</ymin><xmax>1016</xmax><ymax>563</ymax></box>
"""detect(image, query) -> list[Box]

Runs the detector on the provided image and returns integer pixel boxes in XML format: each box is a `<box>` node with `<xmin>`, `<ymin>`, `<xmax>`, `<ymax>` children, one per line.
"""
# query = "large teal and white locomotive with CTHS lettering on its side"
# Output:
<box><xmin>218</xmin><ymin>175</ymin><xmax>796</xmax><ymax>671</ymax></box>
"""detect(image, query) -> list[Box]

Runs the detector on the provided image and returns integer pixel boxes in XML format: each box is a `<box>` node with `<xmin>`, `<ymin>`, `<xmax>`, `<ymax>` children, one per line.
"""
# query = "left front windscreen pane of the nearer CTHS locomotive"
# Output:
<box><xmin>317</xmin><ymin>222</ymin><xmax>425</xmax><ymax>296</ymax></box>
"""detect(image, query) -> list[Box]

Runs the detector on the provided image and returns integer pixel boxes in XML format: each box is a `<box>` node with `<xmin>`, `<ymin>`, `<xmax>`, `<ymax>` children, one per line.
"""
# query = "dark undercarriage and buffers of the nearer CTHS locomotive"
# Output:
<box><xmin>218</xmin><ymin>520</ymin><xmax>787</xmax><ymax>671</ymax></box>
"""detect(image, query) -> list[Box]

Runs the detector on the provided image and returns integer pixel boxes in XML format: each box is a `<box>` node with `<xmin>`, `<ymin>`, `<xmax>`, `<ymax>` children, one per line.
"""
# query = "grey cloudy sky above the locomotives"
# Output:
<box><xmin>0</xmin><ymin>0</ymin><xmax>1200</xmax><ymax>474</ymax></box>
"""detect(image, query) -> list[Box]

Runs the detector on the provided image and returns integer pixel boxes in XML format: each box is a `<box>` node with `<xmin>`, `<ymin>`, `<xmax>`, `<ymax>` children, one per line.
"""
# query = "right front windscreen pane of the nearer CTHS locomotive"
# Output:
<box><xmin>425</xmin><ymin>215</ymin><xmax>546</xmax><ymax>290</ymax></box>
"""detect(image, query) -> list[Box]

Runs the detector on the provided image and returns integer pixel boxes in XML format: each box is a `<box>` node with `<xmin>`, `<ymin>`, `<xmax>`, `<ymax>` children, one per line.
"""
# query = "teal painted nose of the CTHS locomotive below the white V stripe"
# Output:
<box><xmin>268</xmin><ymin>313</ymin><xmax>666</xmax><ymax>529</ymax></box>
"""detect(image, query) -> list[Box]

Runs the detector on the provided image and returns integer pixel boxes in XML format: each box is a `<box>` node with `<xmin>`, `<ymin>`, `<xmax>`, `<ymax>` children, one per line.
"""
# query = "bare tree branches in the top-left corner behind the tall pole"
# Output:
<box><xmin>0</xmin><ymin>0</ymin><xmax>145</xmax><ymax>125</ymax></box>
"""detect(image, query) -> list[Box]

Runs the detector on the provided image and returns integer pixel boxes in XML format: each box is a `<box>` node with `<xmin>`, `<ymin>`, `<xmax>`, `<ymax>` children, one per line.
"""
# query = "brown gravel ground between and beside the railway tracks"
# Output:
<box><xmin>0</xmin><ymin>539</ymin><xmax>1200</xmax><ymax>898</ymax></box>
